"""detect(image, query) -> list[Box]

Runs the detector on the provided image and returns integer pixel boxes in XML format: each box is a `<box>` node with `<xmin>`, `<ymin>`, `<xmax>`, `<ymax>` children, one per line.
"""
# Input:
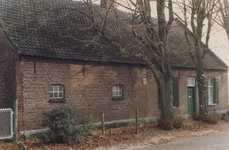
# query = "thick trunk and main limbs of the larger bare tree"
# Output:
<box><xmin>85</xmin><ymin>0</ymin><xmax>174</xmax><ymax>118</ymax></box>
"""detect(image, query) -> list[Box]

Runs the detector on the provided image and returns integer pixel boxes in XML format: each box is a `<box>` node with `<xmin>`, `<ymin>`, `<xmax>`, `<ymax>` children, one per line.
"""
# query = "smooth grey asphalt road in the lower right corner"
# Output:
<box><xmin>135</xmin><ymin>132</ymin><xmax>229</xmax><ymax>150</ymax></box>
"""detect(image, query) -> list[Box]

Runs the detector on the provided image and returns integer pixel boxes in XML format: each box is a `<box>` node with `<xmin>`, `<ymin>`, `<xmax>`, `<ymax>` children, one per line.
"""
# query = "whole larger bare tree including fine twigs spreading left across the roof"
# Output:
<box><xmin>0</xmin><ymin>0</ymin><xmax>174</xmax><ymax>118</ymax></box>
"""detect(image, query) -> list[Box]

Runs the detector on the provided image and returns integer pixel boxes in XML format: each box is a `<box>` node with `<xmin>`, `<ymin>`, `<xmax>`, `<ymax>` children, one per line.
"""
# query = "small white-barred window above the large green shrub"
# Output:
<box><xmin>49</xmin><ymin>85</ymin><xmax>64</xmax><ymax>99</ymax></box>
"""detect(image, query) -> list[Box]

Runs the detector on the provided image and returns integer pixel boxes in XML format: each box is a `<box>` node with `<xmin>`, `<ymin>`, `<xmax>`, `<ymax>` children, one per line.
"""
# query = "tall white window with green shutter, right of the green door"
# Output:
<box><xmin>207</xmin><ymin>78</ymin><xmax>219</xmax><ymax>105</ymax></box>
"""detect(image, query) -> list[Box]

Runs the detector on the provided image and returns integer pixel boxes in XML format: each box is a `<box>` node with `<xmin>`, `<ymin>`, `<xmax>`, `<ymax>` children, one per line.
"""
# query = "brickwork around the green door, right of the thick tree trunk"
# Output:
<box><xmin>173</xmin><ymin>69</ymin><xmax>229</xmax><ymax>114</ymax></box>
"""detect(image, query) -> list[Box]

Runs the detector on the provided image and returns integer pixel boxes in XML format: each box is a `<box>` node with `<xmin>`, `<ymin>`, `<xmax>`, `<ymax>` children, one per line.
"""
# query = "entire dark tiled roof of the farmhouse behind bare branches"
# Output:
<box><xmin>0</xmin><ymin>0</ymin><xmax>227</xmax><ymax>70</ymax></box>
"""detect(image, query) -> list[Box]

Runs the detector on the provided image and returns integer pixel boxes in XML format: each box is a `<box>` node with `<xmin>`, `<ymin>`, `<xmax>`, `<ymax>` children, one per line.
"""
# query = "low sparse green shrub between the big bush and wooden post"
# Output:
<box><xmin>84</xmin><ymin>114</ymin><xmax>99</xmax><ymax>132</ymax></box>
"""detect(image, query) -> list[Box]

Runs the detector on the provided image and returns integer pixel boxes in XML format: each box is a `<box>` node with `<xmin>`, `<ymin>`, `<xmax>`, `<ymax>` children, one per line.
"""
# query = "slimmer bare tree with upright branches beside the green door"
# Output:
<box><xmin>180</xmin><ymin>0</ymin><xmax>218</xmax><ymax>115</ymax></box>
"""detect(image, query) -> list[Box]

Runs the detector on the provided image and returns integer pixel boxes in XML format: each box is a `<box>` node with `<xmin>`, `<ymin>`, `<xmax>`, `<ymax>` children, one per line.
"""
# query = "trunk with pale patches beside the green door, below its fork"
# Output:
<box><xmin>197</xmin><ymin>59</ymin><xmax>208</xmax><ymax>115</ymax></box>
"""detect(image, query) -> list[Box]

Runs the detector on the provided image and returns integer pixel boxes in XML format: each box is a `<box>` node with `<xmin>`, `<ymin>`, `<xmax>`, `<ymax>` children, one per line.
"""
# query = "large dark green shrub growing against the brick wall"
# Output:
<box><xmin>40</xmin><ymin>105</ymin><xmax>84</xmax><ymax>145</ymax></box>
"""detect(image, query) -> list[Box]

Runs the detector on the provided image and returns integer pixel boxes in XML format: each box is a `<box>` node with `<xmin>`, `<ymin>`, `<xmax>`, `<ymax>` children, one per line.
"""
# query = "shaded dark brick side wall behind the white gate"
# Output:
<box><xmin>0</xmin><ymin>29</ymin><xmax>17</xmax><ymax>108</ymax></box>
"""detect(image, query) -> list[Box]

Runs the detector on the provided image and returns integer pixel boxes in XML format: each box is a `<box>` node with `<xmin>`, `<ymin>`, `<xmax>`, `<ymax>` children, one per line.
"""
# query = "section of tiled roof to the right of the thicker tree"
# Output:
<box><xmin>169</xmin><ymin>19</ymin><xmax>228</xmax><ymax>70</ymax></box>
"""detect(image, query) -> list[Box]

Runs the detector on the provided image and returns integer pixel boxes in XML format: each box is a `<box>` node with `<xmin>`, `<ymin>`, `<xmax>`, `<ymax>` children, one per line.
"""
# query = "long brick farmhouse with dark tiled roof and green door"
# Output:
<box><xmin>0</xmin><ymin>1</ymin><xmax>228</xmax><ymax>135</ymax></box>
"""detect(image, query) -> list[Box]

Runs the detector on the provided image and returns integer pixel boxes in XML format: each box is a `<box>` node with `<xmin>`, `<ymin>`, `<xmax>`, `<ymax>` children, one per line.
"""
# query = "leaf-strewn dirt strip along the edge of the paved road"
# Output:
<box><xmin>95</xmin><ymin>120</ymin><xmax>229</xmax><ymax>150</ymax></box>
